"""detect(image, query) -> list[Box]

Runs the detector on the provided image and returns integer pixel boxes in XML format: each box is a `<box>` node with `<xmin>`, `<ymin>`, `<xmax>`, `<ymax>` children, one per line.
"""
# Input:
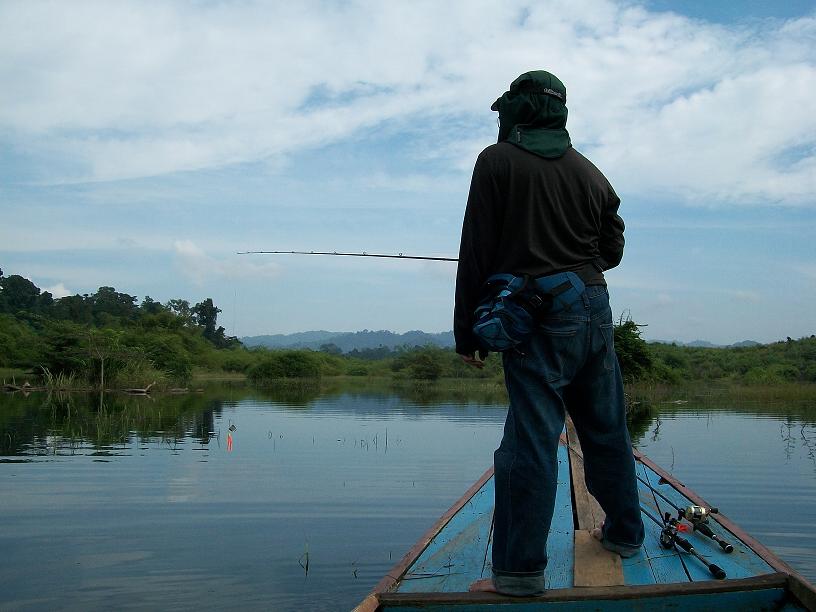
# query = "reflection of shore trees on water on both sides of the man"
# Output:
<box><xmin>0</xmin><ymin>378</ymin><xmax>816</xmax><ymax>464</ymax></box>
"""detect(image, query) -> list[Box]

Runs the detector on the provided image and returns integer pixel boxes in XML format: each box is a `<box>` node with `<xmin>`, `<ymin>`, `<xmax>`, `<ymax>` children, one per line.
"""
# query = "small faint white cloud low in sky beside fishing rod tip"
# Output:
<box><xmin>173</xmin><ymin>240</ymin><xmax>280</xmax><ymax>285</ymax></box>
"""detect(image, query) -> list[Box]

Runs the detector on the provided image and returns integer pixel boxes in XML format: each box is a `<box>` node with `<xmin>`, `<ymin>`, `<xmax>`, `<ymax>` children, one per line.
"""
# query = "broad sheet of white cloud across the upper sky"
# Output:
<box><xmin>0</xmin><ymin>0</ymin><xmax>816</xmax><ymax>206</ymax></box>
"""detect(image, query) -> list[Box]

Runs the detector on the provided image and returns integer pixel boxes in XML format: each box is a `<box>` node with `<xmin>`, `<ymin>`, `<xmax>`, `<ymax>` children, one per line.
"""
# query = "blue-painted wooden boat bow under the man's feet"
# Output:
<box><xmin>355</xmin><ymin>441</ymin><xmax>816</xmax><ymax>612</ymax></box>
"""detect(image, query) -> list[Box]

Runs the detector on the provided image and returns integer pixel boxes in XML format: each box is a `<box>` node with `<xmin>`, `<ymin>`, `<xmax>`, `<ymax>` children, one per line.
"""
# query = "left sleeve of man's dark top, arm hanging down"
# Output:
<box><xmin>453</xmin><ymin>152</ymin><xmax>502</xmax><ymax>355</ymax></box>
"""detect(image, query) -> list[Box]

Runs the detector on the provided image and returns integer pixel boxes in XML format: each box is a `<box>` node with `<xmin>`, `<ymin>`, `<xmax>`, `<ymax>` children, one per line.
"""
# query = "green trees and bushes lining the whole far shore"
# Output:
<box><xmin>0</xmin><ymin>270</ymin><xmax>816</xmax><ymax>406</ymax></box>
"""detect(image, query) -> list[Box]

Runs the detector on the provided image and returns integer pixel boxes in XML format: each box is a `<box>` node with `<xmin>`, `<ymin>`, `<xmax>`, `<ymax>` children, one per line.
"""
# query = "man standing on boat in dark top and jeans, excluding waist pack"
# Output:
<box><xmin>454</xmin><ymin>71</ymin><xmax>644</xmax><ymax>595</ymax></box>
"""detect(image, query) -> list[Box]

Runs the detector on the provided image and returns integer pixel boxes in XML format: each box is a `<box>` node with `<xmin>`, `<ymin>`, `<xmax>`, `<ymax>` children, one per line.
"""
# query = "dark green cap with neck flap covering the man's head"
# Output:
<box><xmin>490</xmin><ymin>70</ymin><xmax>572</xmax><ymax>158</ymax></box>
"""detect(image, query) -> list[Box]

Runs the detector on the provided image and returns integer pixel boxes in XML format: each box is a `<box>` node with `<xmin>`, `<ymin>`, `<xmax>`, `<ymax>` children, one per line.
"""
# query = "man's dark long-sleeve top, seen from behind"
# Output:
<box><xmin>453</xmin><ymin>142</ymin><xmax>624</xmax><ymax>354</ymax></box>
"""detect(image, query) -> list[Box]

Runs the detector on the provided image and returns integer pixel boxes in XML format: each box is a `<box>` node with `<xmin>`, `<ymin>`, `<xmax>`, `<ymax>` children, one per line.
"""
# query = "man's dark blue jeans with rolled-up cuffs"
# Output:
<box><xmin>493</xmin><ymin>285</ymin><xmax>644</xmax><ymax>595</ymax></box>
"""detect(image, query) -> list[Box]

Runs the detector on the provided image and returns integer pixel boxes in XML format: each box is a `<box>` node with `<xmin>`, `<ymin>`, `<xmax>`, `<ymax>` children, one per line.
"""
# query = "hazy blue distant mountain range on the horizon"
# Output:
<box><xmin>241</xmin><ymin>329</ymin><xmax>761</xmax><ymax>353</ymax></box>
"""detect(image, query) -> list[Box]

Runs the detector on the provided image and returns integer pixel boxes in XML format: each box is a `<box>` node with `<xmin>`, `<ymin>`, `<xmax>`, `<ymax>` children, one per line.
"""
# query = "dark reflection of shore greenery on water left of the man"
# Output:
<box><xmin>0</xmin><ymin>381</ymin><xmax>504</xmax><ymax>456</ymax></box>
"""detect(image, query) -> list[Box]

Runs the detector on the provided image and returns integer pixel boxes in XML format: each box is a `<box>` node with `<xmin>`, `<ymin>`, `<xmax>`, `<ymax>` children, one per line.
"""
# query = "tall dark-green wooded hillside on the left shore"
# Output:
<box><xmin>0</xmin><ymin>270</ymin><xmax>240</xmax><ymax>384</ymax></box>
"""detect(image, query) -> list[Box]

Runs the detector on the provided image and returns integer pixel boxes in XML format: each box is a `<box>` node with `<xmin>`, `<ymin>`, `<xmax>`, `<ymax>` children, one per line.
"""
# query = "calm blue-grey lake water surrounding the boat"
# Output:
<box><xmin>0</xmin><ymin>386</ymin><xmax>816</xmax><ymax>610</ymax></box>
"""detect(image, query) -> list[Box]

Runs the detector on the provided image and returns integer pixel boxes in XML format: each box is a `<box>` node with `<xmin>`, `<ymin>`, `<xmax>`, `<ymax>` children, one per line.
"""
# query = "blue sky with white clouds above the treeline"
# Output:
<box><xmin>0</xmin><ymin>0</ymin><xmax>816</xmax><ymax>344</ymax></box>
